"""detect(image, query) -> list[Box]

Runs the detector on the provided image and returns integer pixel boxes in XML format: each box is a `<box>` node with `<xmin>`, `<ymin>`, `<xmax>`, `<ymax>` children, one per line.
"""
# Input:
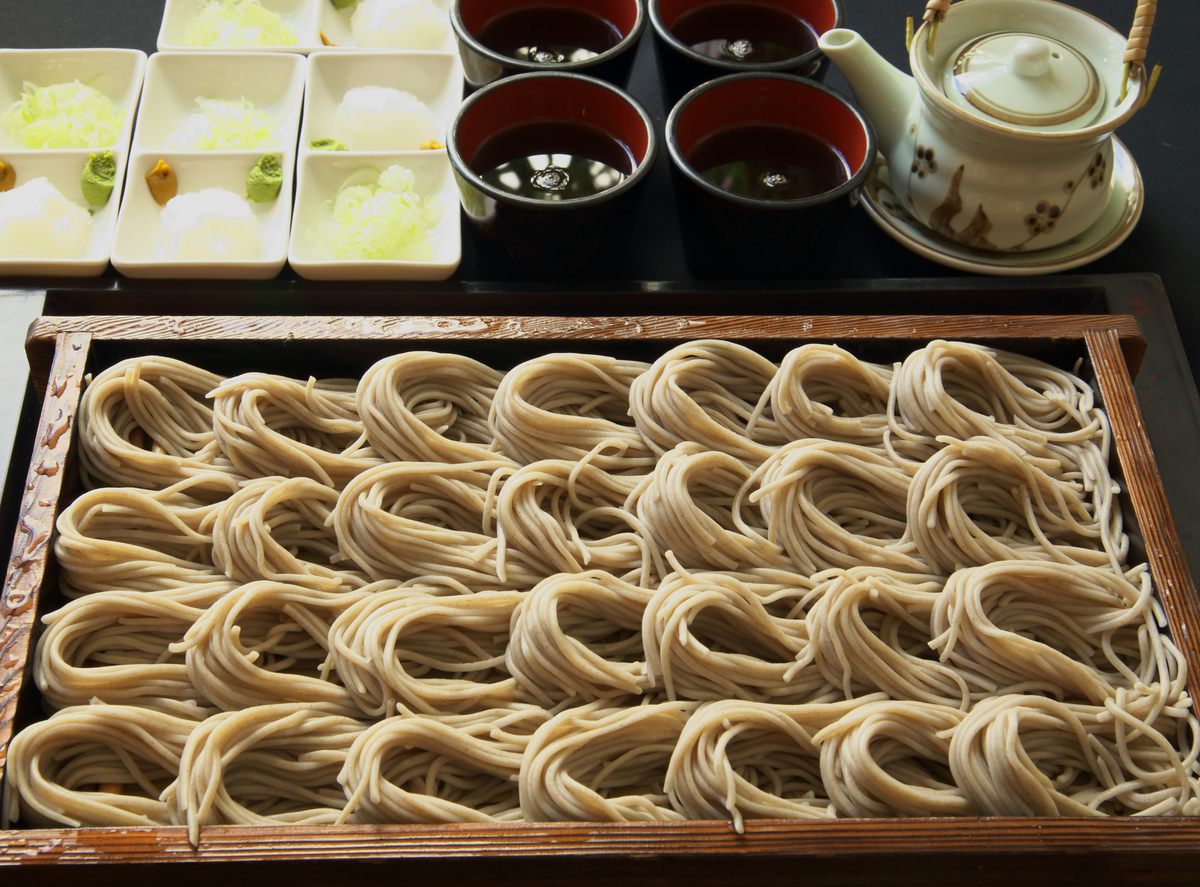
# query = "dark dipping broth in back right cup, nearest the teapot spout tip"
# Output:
<box><xmin>671</xmin><ymin>2</ymin><xmax>817</xmax><ymax>65</ymax></box>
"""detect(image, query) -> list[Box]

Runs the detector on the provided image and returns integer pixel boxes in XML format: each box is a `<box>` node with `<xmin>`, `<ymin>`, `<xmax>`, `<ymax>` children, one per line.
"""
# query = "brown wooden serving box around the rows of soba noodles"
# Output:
<box><xmin>0</xmin><ymin>314</ymin><xmax>1200</xmax><ymax>885</ymax></box>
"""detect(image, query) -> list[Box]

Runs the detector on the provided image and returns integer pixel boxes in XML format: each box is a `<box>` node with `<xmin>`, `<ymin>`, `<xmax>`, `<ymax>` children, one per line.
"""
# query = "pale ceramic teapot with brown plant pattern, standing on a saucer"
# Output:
<box><xmin>820</xmin><ymin>0</ymin><xmax>1148</xmax><ymax>250</ymax></box>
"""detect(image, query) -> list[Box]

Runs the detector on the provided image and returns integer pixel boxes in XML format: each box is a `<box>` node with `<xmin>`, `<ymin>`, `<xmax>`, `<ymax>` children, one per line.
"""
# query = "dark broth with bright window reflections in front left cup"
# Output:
<box><xmin>470</xmin><ymin>120</ymin><xmax>636</xmax><ymax>200</ymax></box>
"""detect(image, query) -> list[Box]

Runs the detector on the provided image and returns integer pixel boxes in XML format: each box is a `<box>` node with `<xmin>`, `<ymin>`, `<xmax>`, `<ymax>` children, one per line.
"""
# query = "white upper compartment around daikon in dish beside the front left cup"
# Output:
<box><xmin>300</xmin><ymin>50</ymin><xmax>462</xmax><ymax>151</ymax></box>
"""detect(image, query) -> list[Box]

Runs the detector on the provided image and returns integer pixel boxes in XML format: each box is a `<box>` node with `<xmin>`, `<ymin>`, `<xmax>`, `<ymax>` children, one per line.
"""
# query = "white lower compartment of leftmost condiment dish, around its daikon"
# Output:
<box><xmin>0</xmin><ymin>149</ymin><xmax>126</xmax><ymax>277</ymax></box>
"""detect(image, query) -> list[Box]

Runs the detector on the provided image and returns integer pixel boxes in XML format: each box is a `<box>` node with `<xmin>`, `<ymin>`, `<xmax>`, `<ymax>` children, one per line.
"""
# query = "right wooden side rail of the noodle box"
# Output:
<box><xmin>1085</xmin><ymin>330</ymin><xmax>1200</xmax><ymax>697</ymax></box>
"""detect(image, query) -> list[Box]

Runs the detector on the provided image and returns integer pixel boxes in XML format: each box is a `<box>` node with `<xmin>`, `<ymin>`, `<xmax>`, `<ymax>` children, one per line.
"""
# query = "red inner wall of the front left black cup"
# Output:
<box><xmin>456</xmin><ymin>74</ymin><xmax>650</xmax><ymax>166</ymax></box>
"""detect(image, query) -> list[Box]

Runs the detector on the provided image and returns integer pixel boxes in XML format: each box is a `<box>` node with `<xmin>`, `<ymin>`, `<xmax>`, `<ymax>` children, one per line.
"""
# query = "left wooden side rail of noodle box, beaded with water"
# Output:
<box><xmin>0</xmin><ymin>332</ymin><xmax>91</xmax><ymax>778</ymax></box>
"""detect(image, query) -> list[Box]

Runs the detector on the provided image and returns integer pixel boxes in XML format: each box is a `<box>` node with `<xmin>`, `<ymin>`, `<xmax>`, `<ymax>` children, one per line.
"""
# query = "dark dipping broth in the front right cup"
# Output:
<box><xmin>688</xmin><ymin>124</ymin><xmax>850</xmax><ymax>200</ymax></box>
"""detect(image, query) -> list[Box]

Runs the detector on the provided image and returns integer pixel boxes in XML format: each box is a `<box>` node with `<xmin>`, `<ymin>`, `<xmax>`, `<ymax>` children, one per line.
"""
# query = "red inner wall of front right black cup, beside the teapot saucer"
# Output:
<box><xmin>674</xmin><ymin>77</ymin><xmax>868</xmax><ymax>176</ymax></box>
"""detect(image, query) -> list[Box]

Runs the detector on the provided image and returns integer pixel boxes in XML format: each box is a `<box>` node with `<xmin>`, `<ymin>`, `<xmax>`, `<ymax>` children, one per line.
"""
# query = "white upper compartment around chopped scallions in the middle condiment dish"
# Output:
<box><xmin>133</xmin><ymin>53</ymin><xmax>307</xmax><ymax>151</ymax></box>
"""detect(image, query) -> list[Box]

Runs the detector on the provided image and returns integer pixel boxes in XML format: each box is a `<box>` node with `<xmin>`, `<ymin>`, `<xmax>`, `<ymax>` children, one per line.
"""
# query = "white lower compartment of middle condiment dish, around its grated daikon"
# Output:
<box><xmin>113</xmin><ymin>151</ymin><xmax>295</xmax><ymax>280</ymax></box>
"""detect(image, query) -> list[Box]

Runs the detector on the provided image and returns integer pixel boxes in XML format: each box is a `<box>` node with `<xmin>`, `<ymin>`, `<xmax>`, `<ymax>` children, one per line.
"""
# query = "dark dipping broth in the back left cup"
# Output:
<box><xmin>475</xmin><ymin>6</ymin><xmax>622</xmax><ymax>65</ymax></box>
